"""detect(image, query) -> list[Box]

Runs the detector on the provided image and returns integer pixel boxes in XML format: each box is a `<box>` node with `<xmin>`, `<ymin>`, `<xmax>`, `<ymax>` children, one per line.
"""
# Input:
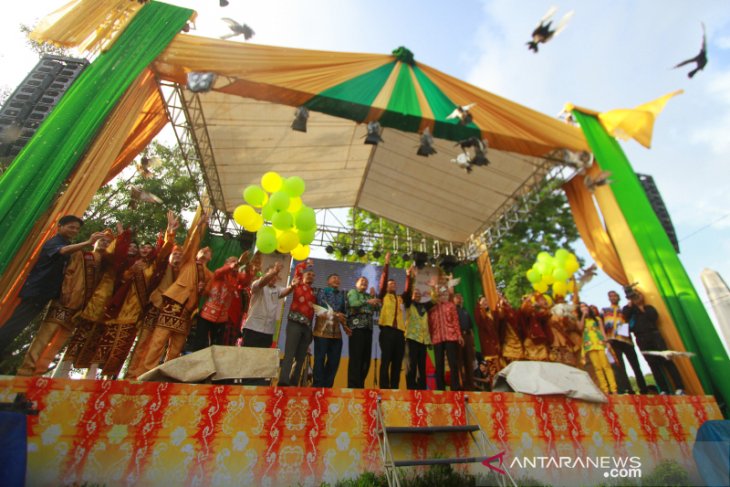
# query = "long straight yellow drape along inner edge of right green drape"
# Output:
<box><xmin>595</xmin><ymin>170</ymin><xmax>704</xmax><ymax>394</ymax></box>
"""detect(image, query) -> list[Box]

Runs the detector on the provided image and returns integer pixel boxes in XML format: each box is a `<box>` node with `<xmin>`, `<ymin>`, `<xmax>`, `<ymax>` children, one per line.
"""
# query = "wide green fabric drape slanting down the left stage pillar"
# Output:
<box><xmin>0</xmin><ymin>2</ymin><xmax>193</xmax><ymax>273</ymax></box>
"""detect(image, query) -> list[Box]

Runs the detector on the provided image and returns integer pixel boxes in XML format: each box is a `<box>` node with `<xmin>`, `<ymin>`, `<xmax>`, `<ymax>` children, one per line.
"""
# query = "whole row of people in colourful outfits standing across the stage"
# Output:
<box><xmin>0</xmin><ymin>213</ymin><xmax>683</xmax><ymax>394</ymax></box>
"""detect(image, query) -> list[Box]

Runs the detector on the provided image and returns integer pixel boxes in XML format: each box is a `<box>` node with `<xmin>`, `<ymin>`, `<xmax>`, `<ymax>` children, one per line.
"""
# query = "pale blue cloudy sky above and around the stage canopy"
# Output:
<box><xmin>0</xmin><ymin>0</ymin><xmax>730</xmax><ymax>354</ymax></box>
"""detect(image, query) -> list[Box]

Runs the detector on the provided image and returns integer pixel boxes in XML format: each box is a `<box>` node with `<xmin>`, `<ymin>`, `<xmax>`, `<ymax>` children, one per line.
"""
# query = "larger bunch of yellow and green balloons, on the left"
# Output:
<box><xmin>233</xmin><ymin>171</ymin><xmax>317</xmax><ymax>260</ymax></box>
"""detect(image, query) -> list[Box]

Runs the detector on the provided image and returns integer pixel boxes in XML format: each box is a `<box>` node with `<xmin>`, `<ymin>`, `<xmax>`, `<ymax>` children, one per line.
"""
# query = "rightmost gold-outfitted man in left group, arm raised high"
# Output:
<box><xmin>142</xmin><ymin>216</ymin><xmax>213</xmax><ymax>372</ymax></box>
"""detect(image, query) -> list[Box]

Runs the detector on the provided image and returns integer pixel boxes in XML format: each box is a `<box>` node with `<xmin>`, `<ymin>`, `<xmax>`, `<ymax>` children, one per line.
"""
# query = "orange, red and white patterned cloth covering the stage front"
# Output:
<box><xmin>0</xmin><ymin>377</ymin><xmax>721</xmax><ymax>486</ymax></box>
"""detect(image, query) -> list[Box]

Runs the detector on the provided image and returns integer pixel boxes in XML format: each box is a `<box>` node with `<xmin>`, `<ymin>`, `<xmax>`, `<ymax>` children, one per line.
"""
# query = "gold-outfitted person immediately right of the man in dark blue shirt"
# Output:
<box><xmin>17</xmin><ymin>231</ymin><xmax>112</xmax><ymax>376</ymax></box>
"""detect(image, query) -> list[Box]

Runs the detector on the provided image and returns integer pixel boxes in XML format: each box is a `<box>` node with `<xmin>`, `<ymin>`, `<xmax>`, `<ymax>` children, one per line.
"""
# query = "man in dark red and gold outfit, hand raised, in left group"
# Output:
<box><xmin>92</xmin><ymin>211</ymin><xmax>179</xmax><ymax>378</ymax></box>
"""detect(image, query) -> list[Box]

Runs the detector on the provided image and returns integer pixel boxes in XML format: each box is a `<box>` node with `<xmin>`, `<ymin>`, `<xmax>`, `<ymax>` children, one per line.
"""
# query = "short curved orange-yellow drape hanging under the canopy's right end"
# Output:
<box><xmin>563</xmin><ymin>164</ymin><xmax>629</xmax><ymax>286</ymax></box>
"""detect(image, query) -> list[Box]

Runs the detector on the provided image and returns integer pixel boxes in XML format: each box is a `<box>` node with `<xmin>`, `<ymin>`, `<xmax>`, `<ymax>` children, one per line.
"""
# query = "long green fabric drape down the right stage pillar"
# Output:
<box><xmin>573</xmin><ymin>111</ymin><xmax>730</xmax><ymax>407</ymax></box>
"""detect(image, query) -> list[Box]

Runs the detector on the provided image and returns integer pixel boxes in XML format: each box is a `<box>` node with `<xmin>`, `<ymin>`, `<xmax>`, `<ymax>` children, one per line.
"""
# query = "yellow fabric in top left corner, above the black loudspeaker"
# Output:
<box><xmin>30</xmin><ymin>0</ymin><xmax>143</xmax><ymax>52</ymax></box>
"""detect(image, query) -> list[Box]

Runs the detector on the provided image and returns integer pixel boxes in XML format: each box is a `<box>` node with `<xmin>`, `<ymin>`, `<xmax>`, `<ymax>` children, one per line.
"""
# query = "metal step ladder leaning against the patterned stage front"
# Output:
<box><xmin>376</xmin><ymin>394</ymin><xmax>517</xmax><ymax>487</ymax></box>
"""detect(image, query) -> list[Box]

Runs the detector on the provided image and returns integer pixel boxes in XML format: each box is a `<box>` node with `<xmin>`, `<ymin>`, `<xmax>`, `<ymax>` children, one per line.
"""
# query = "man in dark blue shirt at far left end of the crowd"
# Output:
<box><xmin>0</xmin><ymin>215</ymin><xmax>104</xmax><ymax>357</ymax></box>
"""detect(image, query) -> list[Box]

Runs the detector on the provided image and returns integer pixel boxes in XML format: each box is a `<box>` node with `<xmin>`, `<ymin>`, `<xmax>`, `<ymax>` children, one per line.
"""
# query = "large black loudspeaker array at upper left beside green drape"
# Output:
<box><xmin>0</xmin><ymin>55</ymin><xmax>89</xmax><ymax>162</ymax></box>
